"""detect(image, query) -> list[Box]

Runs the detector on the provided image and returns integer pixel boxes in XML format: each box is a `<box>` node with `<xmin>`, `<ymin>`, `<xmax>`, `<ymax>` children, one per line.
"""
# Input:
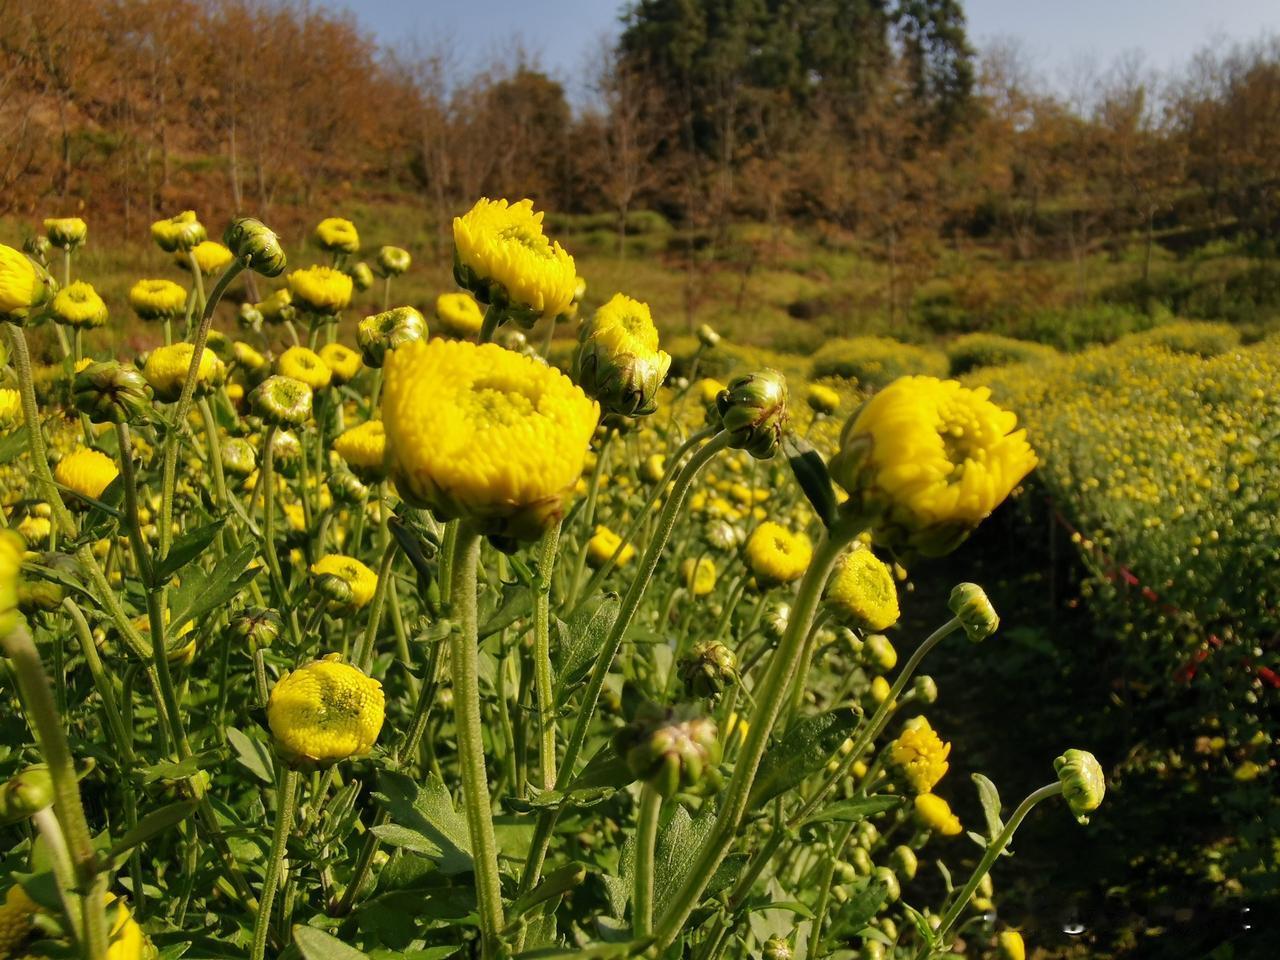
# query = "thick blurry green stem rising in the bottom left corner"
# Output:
<box><xmin>0</xmin><ymin>626</ymin><xmax>108</xmax><ymax>960</ymax></box>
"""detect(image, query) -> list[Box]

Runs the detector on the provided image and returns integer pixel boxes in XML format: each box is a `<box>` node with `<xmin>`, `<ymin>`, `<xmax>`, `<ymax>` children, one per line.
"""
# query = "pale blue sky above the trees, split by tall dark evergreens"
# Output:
<box><xmin>321</xmin><ymin>0</ymin><xmax>1280</xmax><ymax>99</ymax></box>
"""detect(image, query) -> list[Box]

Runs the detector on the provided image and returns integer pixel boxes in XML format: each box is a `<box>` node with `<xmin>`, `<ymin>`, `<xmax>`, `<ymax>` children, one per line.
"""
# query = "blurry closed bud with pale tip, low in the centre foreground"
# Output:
<box><xmin>617</xmin><ymin>704</ymin><xmax>721</xmax><ymax>797</ymax></box>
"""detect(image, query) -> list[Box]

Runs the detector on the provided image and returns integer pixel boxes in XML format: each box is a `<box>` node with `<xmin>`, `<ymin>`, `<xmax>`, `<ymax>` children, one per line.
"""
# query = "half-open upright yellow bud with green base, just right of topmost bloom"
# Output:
<box><xmin>573</xmin><ymin>293</ymin><xmax>671</xmax><ymax>416</ymax></box>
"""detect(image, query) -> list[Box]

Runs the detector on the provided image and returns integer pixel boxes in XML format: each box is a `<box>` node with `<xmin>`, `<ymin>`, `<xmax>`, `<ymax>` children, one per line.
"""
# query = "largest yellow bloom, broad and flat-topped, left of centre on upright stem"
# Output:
<box><xmin>383</xmin><ymin>339</ymin><xmax>599</xmax><ymax>539</ymax></box>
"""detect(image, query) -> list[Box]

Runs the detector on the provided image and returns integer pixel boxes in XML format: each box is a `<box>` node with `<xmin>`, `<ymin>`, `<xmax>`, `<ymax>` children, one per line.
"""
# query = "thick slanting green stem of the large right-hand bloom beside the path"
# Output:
<box><xmin>654</xmin><ymin>516</ymin><xmax>863</xmax><ymax>950</ymax></box>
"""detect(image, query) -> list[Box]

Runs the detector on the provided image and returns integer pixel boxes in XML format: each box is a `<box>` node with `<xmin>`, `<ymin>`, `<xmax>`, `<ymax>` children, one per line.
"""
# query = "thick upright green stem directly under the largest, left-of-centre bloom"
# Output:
<box><xmin>448</xmin><ymin>526</ymin><xmax>503</xmax><ymax>960</ymax></box>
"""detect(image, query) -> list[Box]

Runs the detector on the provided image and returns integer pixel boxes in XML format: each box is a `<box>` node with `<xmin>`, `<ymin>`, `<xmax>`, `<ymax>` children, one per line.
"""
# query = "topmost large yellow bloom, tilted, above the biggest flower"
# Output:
<box><xmin>453</xmin><ymin>198</ymin><xmax>577</xmax><ymax>319</ymax></box>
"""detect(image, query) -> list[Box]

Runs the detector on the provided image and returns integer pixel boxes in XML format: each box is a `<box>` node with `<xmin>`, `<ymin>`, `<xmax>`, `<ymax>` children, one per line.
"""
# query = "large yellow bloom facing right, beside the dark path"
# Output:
<box><xmin>831</xmin><ymin>376</ymin><xmax>1036</xmax><ymax>556</ymax></box>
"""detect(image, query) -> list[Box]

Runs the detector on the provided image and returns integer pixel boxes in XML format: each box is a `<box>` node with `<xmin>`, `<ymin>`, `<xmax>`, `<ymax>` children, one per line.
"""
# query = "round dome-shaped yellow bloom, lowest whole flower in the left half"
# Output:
<box><xmin>266</xmin><ymin>653</ymin><xmax>385</xmax><ymax>764</ymax></box>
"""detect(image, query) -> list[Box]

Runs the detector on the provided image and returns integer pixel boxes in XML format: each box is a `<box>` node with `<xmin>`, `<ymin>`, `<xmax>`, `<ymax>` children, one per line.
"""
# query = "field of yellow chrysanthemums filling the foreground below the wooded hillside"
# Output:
<box><xmin>0</xmin><ymin>200</ymin><xmax>1264</xmax><ymax>960</ymax></box>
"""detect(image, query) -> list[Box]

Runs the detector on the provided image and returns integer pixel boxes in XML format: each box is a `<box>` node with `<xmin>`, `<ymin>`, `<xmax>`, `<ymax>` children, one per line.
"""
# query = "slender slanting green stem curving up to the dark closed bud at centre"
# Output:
<box><xmin>520</xmin><ymin>433</ymin><xmax>731</xmax><ymax>893</ymax></box>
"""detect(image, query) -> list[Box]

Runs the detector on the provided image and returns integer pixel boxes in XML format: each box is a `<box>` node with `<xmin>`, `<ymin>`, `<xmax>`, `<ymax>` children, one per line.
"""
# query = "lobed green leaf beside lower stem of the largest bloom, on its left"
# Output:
<box><xmin>374</xmin><ymin>771</ymin><xmax>472</xmax><ymax>874</ymax></box>
